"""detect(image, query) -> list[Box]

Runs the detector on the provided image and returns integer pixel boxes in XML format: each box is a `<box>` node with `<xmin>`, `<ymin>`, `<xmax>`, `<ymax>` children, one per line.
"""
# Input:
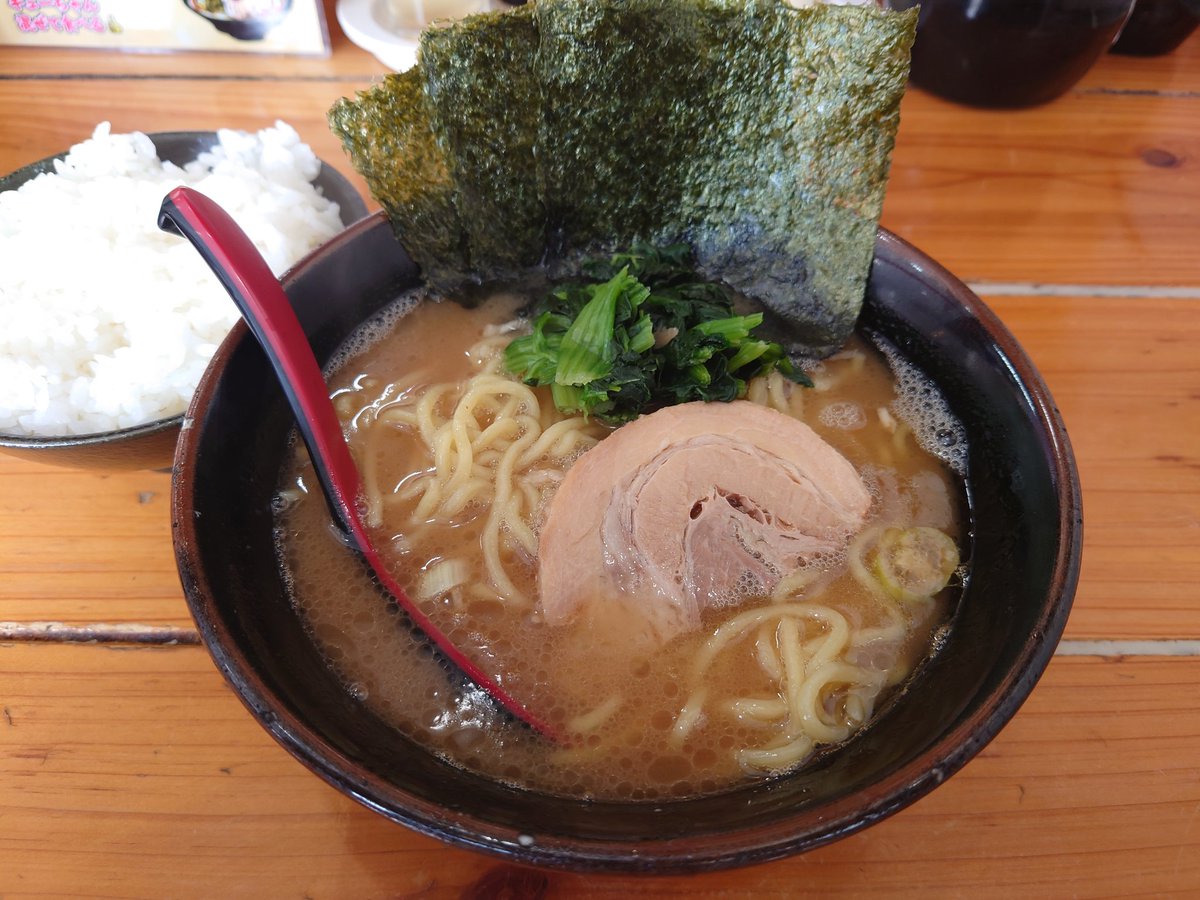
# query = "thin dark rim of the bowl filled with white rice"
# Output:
<box><xmin>0</xmin><ymin>128</ymin><xmax>370</xmax><ymax>451</ymax></box>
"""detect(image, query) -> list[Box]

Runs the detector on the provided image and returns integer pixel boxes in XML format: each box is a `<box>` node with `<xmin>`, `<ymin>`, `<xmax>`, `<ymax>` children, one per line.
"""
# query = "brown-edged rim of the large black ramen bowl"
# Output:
<box><xmin>172</xmin><ymin>218</ymin><xmax>1082</xmax><ymax>874</ymax></box>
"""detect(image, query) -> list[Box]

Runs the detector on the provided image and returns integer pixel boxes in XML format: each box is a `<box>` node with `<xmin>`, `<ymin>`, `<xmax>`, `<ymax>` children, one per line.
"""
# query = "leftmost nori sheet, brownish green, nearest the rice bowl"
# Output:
<box><xmin>329</xmin><ymin>68</ymin><xmax>470</xmax><ymax>284</ymax></box>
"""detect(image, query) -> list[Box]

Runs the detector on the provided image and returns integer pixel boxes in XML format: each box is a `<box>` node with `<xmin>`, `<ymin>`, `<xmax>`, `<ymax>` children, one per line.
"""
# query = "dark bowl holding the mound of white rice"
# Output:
<box><xmin>0</xmin><ymin>131</ymin><xmax>367</xmax><ymax>469</ymax></box>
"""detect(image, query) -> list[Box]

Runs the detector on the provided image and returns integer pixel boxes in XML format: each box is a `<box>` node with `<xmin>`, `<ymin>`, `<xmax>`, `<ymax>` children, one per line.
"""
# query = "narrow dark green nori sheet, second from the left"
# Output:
<box><xmin>420</xmin><ymin>6</ymin><xmax>546</xmax><ymax>278</ymax></box>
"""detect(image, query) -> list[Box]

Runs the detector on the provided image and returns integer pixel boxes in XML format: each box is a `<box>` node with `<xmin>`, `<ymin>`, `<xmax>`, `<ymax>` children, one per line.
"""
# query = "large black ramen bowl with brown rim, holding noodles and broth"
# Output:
<box><xmin>173</xmin><ymin>216</ymin><xmax>1081</xmax><ymax>872</ymax></box>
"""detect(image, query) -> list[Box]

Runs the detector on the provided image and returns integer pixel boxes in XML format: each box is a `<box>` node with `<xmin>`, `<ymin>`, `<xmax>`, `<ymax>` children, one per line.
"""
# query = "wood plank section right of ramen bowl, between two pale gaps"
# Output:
<box><xmin>988</xmin><ymin>296</ymin><xmax>1200</xmax><ymax>640</ymax></box>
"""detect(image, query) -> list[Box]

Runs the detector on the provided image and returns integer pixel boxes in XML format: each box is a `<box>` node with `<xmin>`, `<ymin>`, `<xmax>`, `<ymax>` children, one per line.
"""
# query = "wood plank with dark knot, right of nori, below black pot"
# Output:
<box><xmin>883</xmin><ymin>92</ymin><xmax>1200</xmax><ymax>287</ymax></box>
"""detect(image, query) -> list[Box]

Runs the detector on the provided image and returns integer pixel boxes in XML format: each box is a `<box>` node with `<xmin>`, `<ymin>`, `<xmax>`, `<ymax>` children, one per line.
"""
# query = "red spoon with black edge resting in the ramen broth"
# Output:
<box><xmin>158</xmin><ymin>187</ymin><xmax>558</xmax><ymax>739</ymax></box>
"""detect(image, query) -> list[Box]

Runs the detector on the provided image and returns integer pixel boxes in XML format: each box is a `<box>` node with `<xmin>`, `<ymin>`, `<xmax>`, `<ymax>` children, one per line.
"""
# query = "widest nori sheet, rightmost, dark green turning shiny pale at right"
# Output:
<box><xmin>535</xmin><ymin>0</ymin><xmax>916</xmax><ymax>354</ymax></box>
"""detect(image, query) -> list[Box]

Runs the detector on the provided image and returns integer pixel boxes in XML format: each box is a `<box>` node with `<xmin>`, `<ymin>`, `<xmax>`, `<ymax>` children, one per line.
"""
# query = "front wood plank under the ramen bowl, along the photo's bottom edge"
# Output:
<box><xmin>0</xmin><ymin>646</ymin><xmax>1200</xmax><ymax>898</ymax></box>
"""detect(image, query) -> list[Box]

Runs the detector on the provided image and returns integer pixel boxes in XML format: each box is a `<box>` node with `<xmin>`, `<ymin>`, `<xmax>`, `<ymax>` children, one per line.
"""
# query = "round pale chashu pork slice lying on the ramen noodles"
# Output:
<box><xmin>538</xmin><ymin>401</ymin><xmax>871</xmax><ymax>642</ymax></box>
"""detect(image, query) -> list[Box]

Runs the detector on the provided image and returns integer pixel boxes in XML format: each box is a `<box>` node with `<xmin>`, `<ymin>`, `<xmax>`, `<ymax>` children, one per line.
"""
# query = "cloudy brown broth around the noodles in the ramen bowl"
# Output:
<box><xmin>278</xmin><ymin>292</ymin><xmax>962</xmax><ymax>799</ymax></box>
